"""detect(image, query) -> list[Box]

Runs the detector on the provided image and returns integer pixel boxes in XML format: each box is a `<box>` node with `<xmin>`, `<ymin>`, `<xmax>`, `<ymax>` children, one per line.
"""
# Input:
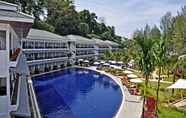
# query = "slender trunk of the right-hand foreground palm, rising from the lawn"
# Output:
<box><xmin>156</xmin><ymin>67</ymin><xmax>161</xmax><ymax>118</ymax></box>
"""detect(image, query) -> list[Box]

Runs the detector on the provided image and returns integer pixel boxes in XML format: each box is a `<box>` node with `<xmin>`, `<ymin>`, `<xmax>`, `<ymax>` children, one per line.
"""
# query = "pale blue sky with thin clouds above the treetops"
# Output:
<box><xmin>75</xmin><ymin>0</ymin><xmax>186</xmax><ymax>38</ymax></box>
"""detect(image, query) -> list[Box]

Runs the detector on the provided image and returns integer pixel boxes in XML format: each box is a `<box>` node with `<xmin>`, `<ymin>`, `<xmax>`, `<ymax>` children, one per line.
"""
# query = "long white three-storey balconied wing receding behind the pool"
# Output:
<box><xmin>21</xmin><ymin>29</ymin><xmax>119</xmax><ymax>75</ymax></box>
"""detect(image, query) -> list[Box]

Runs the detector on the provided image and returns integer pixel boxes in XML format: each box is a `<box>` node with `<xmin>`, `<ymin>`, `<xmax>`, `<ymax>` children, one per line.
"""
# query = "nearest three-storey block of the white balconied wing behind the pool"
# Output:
<box><xmin>21</xmin><ymin>29</ymin><xmax>70</xmax><ymax>74</ymax></box>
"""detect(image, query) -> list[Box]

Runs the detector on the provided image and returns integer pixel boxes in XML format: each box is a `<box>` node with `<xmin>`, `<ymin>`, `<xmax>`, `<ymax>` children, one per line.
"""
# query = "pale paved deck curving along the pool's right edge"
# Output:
<box><xmin>88</xmin><ymin>67</ymin><xmax>143</xmax><ymax>118</ymax></box>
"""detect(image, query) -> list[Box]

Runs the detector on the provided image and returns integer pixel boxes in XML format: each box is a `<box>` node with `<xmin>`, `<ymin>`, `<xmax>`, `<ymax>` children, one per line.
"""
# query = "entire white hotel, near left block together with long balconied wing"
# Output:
<box><xmin>0</xmin><ymin>1</ymin><xmax>118</xmax><ymax>118</ymax></box>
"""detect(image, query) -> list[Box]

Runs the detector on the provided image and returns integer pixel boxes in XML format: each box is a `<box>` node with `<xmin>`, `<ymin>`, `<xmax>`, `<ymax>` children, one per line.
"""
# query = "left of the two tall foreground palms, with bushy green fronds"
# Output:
<box><xmin>134</xmin><ymin>26</ymin><xmax>155</xmax><ymax>117</ymax></box>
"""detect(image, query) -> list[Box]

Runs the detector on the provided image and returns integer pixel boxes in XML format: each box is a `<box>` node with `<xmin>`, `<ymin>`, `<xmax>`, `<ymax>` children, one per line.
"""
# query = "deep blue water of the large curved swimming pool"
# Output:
<box><xmin>33</xmin><ymin>68</ymin><xmax>122</xmax><ymax>118</ymax></box>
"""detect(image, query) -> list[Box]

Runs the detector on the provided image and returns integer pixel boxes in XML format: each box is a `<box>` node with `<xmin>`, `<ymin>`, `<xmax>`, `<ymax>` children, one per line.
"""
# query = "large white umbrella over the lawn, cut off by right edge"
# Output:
<box><xmin>167</xmin><ymin>79</ymin><xmax>186</xmax><ymax>89</ymax></box>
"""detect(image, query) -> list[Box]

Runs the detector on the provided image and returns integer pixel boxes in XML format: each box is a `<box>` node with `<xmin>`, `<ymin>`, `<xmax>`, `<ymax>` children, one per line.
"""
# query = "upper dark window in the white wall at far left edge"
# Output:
<box><xmin>0</xmin><ymin>31</ymin><xmax>6</xmax><ymax>50</ymax></box>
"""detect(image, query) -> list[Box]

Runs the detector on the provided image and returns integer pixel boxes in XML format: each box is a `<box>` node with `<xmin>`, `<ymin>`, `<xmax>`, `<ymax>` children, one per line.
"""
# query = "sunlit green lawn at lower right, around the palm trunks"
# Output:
<box><xmin>139</xmin><ymin>82</ymin><xmax>186</xmax><ymax>118</ymax></box>
